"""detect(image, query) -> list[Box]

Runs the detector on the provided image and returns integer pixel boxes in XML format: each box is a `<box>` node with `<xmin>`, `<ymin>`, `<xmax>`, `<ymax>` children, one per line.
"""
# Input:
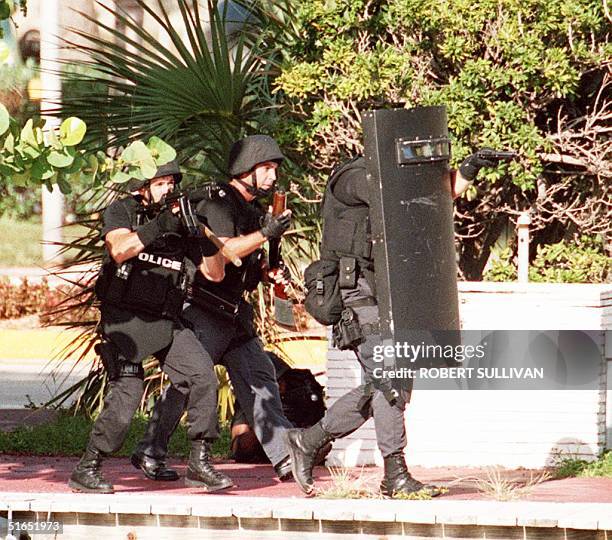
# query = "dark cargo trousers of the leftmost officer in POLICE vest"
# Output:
<box><xmin>89</xmin><ymin>328</ymin><xmax>219</xmax><ymax>454</ymax></box>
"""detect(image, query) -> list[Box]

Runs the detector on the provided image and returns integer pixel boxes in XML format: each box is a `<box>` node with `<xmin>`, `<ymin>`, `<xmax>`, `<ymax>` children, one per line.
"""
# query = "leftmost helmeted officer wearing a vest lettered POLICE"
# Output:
<box><xmin>69</xmin><ymin>161</ymin><xmax>232</xmax><ymax>493</ymax></box>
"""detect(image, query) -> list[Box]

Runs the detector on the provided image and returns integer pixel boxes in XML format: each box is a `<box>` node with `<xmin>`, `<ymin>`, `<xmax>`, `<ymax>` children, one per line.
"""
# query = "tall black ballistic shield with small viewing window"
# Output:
<box><xmin>362</xmin><ymin>107</ymin><xmax>459</xmax><ymax>365</ymax></box>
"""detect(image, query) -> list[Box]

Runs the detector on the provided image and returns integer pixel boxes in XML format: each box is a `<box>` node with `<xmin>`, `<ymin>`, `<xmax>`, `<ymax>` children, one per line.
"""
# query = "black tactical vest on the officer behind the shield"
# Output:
<box><xmin>321</xmin><ymin>157</ymin><xmax>374</xmax><ymax>277</ymax></box>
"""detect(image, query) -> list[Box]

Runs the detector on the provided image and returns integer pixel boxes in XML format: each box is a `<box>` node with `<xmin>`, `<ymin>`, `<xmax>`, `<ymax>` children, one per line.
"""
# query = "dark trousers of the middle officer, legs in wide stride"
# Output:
<box><xmin>138</xmin><ymin>304</ymin><xmax>293</xmax><ymax>465</ymax></box>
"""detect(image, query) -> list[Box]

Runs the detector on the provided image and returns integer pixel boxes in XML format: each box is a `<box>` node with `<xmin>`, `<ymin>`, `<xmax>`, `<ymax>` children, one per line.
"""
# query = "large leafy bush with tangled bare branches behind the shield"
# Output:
<box><xmin>275</xmin><ymin>0</ymin><xmax>612</xmax><ymax>279</ymax></box>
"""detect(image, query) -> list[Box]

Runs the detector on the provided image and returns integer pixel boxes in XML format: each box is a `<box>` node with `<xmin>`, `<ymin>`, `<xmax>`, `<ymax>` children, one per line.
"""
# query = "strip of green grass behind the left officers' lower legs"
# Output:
<box><xmin>0</xmin><ymin>412</ymin><xmax>230</xmax><ymax>458</ymax></box>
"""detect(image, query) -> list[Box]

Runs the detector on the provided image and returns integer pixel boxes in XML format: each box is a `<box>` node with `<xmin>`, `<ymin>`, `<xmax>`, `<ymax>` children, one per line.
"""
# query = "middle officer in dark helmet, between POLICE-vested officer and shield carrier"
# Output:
<box><xmin>133</xmin><ymin>135</ymin><xmax>293</xmax><ymax>480</ymax></box>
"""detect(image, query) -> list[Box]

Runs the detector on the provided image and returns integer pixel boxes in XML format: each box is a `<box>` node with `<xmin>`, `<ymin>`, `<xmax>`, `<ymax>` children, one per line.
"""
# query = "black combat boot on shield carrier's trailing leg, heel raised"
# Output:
<box><xmin>285</xmin><ymin>422</ymin><xmax>334</xmax><ymax>495</ymax></box>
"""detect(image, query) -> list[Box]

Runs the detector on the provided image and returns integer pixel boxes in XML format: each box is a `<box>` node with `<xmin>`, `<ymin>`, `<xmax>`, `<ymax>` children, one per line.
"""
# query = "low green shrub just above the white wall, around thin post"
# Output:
<box><xmin>484</xmin><ymin>236</ymin><xmax>612</xmax><ymax>283</ymax></box>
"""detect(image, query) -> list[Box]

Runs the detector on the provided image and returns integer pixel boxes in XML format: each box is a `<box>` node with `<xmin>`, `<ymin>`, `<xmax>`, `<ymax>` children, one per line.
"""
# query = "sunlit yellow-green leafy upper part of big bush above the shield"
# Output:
<box><xmin>276</xmin><ymin>0</ymin><xmax>609</xmax><ymax>167</ymax></box>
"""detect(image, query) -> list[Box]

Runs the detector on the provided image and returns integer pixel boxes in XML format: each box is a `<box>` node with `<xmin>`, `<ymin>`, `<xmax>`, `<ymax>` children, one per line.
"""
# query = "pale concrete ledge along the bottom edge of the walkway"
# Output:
<box><xmin>0</xmin><ymin>493</ymin><xmax>612</xmax><ymax>538</ymax></box>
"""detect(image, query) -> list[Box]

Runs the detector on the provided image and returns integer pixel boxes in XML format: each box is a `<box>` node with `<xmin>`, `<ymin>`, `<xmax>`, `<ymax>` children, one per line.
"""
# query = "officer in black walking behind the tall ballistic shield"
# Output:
<box><xmin>286</xmin><ymin>150</ymin><xmax>495</xmax><ymax>497</ymax></box>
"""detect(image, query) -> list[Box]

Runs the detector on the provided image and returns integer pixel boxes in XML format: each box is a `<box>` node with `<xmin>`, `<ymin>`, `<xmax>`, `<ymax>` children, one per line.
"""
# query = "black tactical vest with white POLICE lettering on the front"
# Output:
<box><xmin>96</xmin><ymin>198</ymin><xmax>188</xmax><ymax>319</ymax></box>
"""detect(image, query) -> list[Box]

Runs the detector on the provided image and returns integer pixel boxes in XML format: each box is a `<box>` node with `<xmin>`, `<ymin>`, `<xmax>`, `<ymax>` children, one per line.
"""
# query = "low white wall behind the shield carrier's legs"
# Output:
<box><xmin>327</xmin><ymin>283</ymin><xmax>612</xmax><ymax>467</ymax></box>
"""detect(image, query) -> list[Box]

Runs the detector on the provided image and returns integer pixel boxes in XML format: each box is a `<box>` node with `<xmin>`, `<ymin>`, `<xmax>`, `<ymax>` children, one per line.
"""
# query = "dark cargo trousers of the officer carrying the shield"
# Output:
<box><xmin>321</xmin><ymin>277</ymin><xmax>409</xmax><ymax>457</ymax></box>
